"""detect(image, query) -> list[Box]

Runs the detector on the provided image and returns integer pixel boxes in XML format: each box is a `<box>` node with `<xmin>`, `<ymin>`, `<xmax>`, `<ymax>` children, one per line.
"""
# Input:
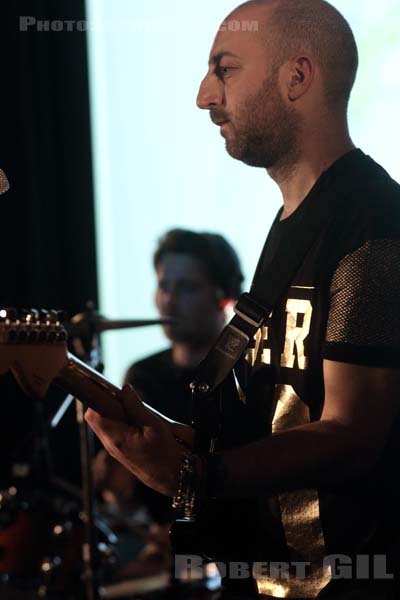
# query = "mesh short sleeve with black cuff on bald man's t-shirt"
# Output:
<box><xmin>323</xmin><ymin>239</ymin><xmax>400</xmax><ymax>367</ymax></box>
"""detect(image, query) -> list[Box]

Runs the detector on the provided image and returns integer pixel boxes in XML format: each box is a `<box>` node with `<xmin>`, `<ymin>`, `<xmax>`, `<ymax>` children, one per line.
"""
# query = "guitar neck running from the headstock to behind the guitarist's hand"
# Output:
<box><xmin>54</xmin><ymin>353</ymin><xmax>193</xmax><ymax>445</ymax></box>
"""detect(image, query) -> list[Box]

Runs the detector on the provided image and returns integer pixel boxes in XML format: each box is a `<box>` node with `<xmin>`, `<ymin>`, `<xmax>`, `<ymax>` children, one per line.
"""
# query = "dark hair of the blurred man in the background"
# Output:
<box><xmin>153</xmin><ymin>229</ymin><xmax>243</xmax><ymax>298</ymax></box>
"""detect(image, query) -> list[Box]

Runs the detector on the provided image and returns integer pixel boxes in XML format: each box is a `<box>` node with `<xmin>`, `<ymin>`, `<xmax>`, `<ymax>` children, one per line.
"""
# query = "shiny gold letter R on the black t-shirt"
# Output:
<box><xmin>281</xmin><ymin>298</ymin><xmax>312</xmax><ymax>371</ymax></box>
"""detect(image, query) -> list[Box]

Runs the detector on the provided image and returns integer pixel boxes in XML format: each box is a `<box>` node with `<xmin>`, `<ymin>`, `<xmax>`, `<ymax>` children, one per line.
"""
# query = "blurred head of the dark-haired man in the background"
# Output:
<box><xmin>154</xmin><ymin>229</ymin><xmax>243</xmax><ymax>345</ymax></box>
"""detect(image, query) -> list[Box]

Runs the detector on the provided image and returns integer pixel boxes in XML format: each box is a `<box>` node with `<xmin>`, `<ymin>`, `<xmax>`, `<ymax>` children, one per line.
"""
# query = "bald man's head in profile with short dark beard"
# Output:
<box><xmin>197</xmin><ymin>0</ymin><xmax>358</xmax><ymax>168</ymax></box>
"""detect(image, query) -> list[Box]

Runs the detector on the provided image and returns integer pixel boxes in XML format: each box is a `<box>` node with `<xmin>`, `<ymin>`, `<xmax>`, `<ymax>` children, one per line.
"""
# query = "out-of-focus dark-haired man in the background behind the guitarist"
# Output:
<box><xmin>94</xmin><ymin>229</ymin><xmax>243</xmax><ymax>548</ymax></box>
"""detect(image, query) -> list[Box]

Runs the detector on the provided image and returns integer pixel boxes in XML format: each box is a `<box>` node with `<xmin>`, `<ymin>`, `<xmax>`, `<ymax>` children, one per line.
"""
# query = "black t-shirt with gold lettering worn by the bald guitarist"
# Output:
<box><xmin>247</xmin><ymin>150</ymin><xmax>400</xmax><ymax>598</ymax></box>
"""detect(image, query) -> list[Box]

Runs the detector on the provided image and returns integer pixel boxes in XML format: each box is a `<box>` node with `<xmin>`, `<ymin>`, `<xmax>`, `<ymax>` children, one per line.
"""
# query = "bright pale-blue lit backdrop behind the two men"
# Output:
<box><xmin>87</xmin><ymin>0</ymin><xmax>400</xmax><ymax>383</ymax></box>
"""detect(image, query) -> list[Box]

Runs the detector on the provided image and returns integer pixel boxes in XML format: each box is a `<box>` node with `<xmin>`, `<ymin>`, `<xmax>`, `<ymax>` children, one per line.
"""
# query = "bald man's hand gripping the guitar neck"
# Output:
<box><xmin>85</xmin><ymin>385</ymin><xmax>183</xmax><ymax>496</ymax></box>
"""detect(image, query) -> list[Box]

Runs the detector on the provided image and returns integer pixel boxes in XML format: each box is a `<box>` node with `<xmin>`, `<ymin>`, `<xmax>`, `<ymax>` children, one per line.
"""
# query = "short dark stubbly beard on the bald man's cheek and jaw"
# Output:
<box><xmin>226</xmin><ymin>73</ymin><xmax>302</xmax><ymax>169</ymax></box>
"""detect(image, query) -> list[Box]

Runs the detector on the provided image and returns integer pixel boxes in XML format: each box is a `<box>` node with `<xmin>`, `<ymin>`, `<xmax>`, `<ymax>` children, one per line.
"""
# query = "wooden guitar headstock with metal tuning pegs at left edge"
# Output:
<box><xmin>0</xmin><ymin>308</ymin><xmax>68</xmax><ymax>397</ymax></box>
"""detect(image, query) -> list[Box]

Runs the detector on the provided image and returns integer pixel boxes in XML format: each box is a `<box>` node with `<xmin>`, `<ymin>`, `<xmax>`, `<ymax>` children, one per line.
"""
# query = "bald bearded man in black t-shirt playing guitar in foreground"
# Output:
<box><xmin>87</xmin><ymin>0</ymin><xmax>400</xmax><ymax>600</ymax></box>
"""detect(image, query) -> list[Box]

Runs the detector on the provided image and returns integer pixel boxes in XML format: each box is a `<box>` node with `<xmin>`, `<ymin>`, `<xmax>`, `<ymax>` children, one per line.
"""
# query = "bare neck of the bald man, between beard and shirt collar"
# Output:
<box><xmin>268</xmin><ymin>118</ymin><xmax>355</xmax><ymax>220</ymax></box>
